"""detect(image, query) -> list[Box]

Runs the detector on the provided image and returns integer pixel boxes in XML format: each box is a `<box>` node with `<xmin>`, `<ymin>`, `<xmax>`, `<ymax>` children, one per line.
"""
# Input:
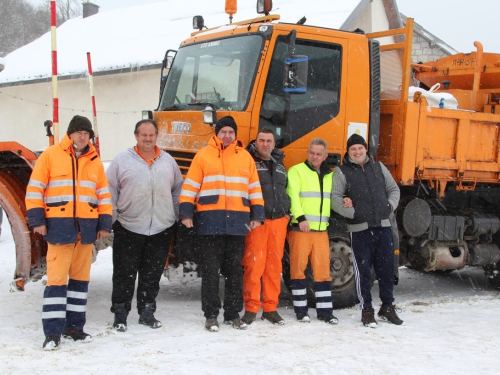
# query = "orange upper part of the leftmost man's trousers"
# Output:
<box><xmin>46</xmin><ymin>235</ymin><xmax>93</xmax><ymax>286</ymax></box>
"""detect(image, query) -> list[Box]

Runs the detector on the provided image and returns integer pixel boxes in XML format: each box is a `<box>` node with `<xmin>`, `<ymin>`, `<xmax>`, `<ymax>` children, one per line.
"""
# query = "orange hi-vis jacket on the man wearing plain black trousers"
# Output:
<box><xmin>179</xmin><ymin>136</ymin><xmax>264</xmax><ymax>236</ymax></box>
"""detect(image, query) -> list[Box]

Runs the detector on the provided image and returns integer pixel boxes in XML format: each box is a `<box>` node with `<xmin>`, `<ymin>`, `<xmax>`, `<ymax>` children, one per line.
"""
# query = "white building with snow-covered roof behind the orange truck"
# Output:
<box><xmin>0</xmin><ymin>0</ymin><xmax>454</xmax><ymax>160</ymax></box>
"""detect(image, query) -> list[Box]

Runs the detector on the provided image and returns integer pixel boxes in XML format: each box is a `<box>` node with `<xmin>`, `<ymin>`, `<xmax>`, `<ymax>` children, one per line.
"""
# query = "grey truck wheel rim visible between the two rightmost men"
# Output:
<box><xmin>330</xmin><ymin>237</ymin><xmax>354</xmax><ymax>292</ymax></box>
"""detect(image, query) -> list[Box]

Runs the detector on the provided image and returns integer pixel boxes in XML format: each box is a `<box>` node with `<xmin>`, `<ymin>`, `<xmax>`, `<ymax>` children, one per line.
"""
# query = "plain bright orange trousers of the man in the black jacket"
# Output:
<box><xmin>242</xmin><ymin>216</ymin><xmax>288</xmax><ymax>313</ymax></box>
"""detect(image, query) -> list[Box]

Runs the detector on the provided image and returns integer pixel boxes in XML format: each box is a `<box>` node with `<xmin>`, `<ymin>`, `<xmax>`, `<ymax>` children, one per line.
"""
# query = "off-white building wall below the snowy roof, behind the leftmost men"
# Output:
<box><xmin>0</xmin><ymin>69</ymin><xmax>160</xmax><ymax>160</ymax></box>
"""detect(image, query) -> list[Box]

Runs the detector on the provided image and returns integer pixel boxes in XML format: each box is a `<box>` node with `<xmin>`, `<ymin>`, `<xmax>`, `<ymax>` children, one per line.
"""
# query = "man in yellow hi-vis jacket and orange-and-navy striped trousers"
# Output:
<box><xmin>287</xmin><ymin>138</ymin><xmax>338</xmax><ymax>324</ymax></box>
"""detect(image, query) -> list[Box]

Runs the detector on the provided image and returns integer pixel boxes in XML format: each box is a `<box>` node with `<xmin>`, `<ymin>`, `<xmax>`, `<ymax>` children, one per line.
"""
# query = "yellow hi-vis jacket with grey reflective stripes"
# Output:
<box><xmin>286</xmin><ymin>161</ymin><xmax>332</xmax><ymax>231</ymax></box>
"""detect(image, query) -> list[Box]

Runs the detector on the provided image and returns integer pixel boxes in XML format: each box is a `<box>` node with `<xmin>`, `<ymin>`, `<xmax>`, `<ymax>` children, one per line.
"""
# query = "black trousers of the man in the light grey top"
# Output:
<box><xmin>111</xmin><ymin>221</ymin><xmax>173</xmax><ymax>314</ymax></box>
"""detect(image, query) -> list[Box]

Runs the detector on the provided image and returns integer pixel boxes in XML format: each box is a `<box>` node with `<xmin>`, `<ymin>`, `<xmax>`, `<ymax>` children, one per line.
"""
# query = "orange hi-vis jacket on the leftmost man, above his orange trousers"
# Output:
<box><xmin>26</xmin><ymin>134</ymin><xmax>113</xmax><ymax>244</ymax></box>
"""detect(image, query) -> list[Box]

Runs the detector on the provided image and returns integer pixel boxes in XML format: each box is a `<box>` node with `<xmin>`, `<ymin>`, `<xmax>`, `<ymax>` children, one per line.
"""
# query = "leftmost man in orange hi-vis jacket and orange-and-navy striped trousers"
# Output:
<box><xmin>26</xmin><ymin>116</ymin><xmax>113</xmax><ymax>350</ymax></box>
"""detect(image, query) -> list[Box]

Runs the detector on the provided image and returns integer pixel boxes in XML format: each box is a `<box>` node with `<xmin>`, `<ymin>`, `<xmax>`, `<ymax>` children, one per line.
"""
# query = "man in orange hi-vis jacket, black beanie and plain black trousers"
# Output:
<box><xmin>179</xmin><ymin>116</ymin><xmax>264</xmax><ymax>332</ymax></box>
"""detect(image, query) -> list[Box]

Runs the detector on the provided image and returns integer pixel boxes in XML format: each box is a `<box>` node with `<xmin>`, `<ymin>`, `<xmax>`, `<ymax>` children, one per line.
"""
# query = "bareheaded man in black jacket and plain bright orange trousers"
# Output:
<box><xmin>242</xmin><ymin>129</ymin><xmax>290</xmax><ymax>325</ymax></box>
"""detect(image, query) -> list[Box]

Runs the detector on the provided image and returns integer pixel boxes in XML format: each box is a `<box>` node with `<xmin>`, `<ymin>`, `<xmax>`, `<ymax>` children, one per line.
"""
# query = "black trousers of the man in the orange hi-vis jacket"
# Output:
<box><xmin>198</xmin><ymin>235</ymin><xmax>245</xmax><ymax>320</ymax></box>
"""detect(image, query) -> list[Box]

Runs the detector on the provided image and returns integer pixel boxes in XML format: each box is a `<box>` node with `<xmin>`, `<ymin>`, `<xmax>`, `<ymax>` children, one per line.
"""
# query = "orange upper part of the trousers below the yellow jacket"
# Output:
<box><xmin>288</xmin><ymin>231</ymin><xmax>332</xmax><ymax>282</ymax></box>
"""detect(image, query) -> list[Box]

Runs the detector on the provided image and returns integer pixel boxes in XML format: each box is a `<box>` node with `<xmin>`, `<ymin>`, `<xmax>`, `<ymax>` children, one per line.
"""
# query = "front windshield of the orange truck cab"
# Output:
<box><xmin>159</xmin><ymin>35</ymin><xmax>263</xmax><ymax>111</ymax></box>
